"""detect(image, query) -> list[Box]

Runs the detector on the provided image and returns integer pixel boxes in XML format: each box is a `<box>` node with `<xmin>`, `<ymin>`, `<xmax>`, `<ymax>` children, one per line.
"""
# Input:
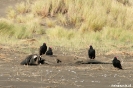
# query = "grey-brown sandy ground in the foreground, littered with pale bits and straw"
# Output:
<box><xmin>0</xmin><ymin>45</ymin><xmax>133</xmax><ymax>88</ymax></box>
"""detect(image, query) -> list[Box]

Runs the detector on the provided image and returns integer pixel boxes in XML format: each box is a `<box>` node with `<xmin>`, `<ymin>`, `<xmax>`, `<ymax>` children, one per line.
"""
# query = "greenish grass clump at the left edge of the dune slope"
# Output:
<box><xmin>0</xmin><ymin>17</ymin><xmax>44</xmax><ymax>39</ymax></box>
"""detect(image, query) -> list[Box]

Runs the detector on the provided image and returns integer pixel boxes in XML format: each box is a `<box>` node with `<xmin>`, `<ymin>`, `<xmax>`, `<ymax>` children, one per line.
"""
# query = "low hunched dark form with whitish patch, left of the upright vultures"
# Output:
<box><xmin>20</xmin><ymin>54</ymin><xmax>39</xmax><ymax>65</ymax></box>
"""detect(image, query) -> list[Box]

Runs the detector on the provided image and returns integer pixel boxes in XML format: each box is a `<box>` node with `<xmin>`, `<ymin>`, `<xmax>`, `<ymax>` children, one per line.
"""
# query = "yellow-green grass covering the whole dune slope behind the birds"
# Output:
<box><xmin>0</xmin><ymin>0</ymin><xmax>133</xmax><ymax>53</ymax></box>
